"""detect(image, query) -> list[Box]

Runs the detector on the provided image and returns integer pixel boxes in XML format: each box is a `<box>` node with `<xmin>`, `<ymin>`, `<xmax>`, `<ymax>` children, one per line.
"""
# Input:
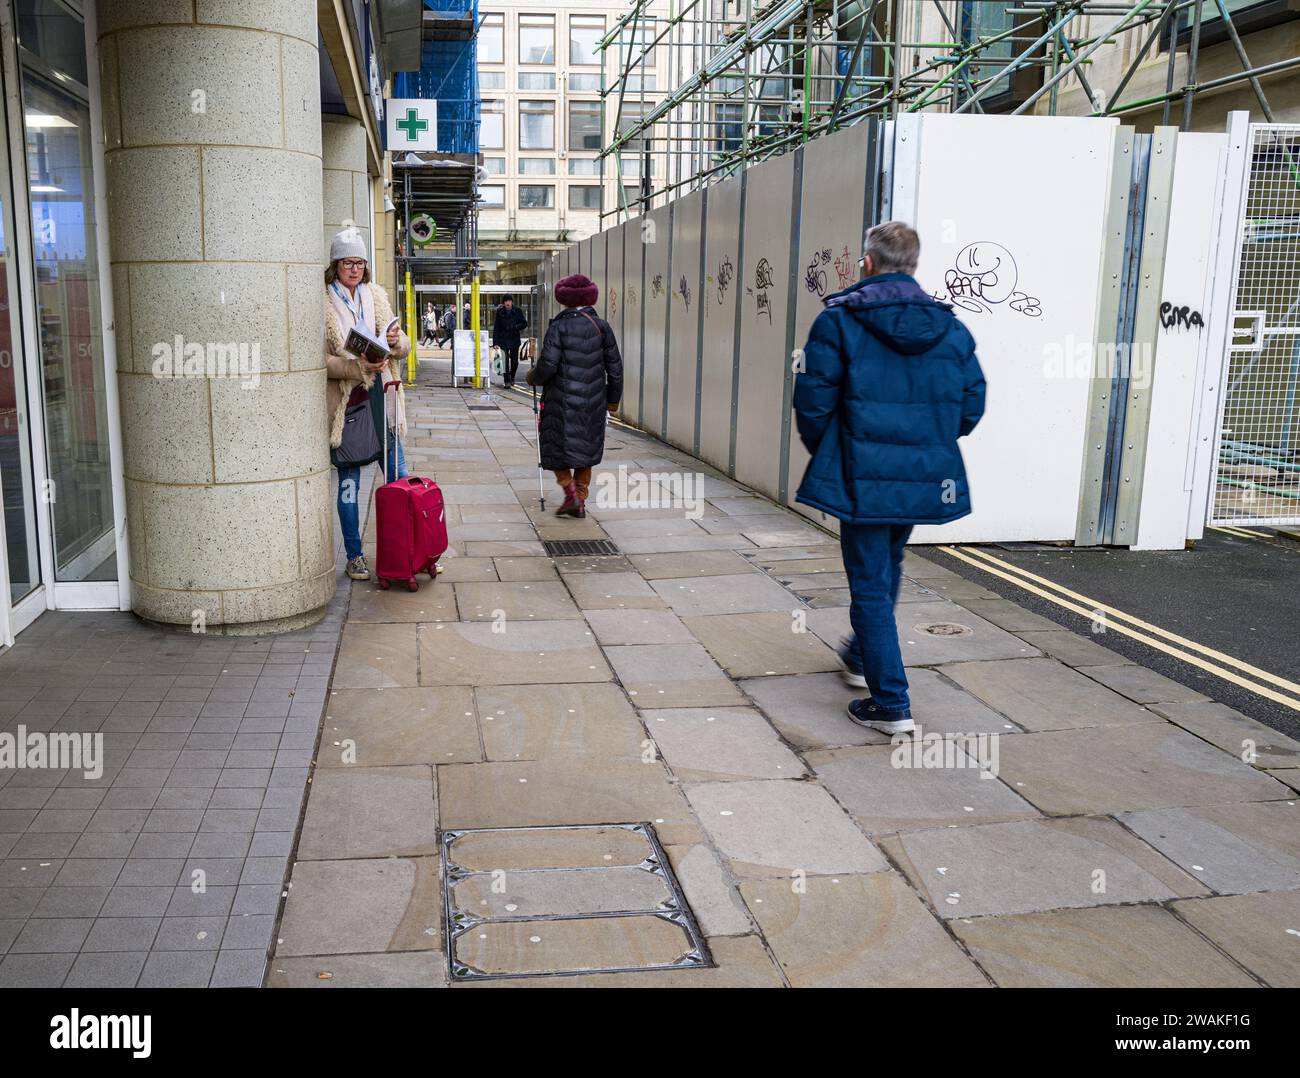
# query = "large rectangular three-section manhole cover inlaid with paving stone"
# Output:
<box><xmin>441</xmin><ymin>823</ymin><xmax>714</xmax><ymax>982</ymax></box>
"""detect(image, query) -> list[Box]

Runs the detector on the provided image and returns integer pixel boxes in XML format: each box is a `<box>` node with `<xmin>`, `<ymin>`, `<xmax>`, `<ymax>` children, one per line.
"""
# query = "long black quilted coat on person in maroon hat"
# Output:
<box><xmin>532</xmin><ymin>307</ymin><xmax>623</xmax><ymax>469</ymax></box>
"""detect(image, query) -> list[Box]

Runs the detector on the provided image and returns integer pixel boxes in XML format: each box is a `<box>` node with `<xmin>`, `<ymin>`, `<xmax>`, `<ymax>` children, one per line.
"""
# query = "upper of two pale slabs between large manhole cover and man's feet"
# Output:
<box><xmin>645</xmin><ymin>707</ymin><xmax>807</xmax><ymax>783</ymax></box>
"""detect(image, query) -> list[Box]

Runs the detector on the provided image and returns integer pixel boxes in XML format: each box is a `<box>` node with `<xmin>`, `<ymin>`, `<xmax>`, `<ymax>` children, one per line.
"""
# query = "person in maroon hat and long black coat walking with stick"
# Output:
<box><xmin>528</xmin><ymin>273</ymin><xmax>623</xmax><ymax>516</ymax></box>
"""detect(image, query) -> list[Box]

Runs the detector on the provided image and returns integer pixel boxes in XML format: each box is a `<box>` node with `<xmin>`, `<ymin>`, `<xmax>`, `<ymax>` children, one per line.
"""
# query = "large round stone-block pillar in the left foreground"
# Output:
<box><xmin>98</xmin><ymin>0</ymin><xmax>334</xmax><ymax>632</ymax></box>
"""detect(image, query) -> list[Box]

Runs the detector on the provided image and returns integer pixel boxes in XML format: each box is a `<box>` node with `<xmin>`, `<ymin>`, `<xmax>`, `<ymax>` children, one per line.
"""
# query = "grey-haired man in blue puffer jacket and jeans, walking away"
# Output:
<box><xmin>794</xmin><ymin>221</ymin><xmax>984</xmax><ymax>733</ymax></box>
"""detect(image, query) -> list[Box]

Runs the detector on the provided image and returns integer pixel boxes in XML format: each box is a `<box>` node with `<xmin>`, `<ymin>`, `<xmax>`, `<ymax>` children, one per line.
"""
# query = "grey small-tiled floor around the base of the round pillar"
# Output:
<box><xmin>0</xmin><ymin>469</ymin><xmax>373</xmax><ymax>987</ymax></box>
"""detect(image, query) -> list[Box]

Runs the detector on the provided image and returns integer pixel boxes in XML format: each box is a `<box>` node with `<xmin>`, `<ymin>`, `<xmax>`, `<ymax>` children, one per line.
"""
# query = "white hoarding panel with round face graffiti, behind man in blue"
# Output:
<box><xmin>893</xmin><ymin>114</ymin><xmax>1114</xmax><ymax>542</ymax></box>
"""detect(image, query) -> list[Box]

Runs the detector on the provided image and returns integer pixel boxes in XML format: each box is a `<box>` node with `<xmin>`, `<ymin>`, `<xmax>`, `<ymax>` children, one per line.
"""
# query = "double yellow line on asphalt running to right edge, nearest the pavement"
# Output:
<box><xmin>939</xmin><ymin>546</ymin><xmax>1300</xmax><ymax>711</ymax></box>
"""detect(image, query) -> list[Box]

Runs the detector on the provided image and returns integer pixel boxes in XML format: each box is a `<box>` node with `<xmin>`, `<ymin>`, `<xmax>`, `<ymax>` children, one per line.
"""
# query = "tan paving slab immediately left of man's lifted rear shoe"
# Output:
<box><xmin>683</xmin><ymin>613</ymin><xmax>840</xmax><ymax>677</ymax></box>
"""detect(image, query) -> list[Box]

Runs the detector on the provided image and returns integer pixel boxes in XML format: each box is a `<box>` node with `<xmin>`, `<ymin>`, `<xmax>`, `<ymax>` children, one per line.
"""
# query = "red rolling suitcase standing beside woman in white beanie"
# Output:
<box><xmin>374</xmin><ymin>382</ymin><xmax>447</xmax><ymax>592</ymax></box>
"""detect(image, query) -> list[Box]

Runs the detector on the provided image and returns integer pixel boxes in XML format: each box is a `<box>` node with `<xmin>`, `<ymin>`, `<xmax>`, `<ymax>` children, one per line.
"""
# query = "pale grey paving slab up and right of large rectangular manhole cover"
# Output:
<box><xmin>686</xmin><ymin>780</ymin><xmax>888</xmax><ymax>879</ymax></box>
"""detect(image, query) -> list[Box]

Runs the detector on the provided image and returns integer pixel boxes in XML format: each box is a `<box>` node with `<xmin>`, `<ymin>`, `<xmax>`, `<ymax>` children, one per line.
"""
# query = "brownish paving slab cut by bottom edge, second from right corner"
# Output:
<box><xmin>949</xmin><ymin>906</ymin><xmax>1258</xmax><ymax>988</ymax></box>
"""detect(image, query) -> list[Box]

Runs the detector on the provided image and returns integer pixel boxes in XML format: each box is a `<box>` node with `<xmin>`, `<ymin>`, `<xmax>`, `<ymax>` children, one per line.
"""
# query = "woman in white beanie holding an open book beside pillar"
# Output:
<box><xmin>325</xmin><ymin>225</ymin><xmax>411</xmax><ymax>580</ymax></box>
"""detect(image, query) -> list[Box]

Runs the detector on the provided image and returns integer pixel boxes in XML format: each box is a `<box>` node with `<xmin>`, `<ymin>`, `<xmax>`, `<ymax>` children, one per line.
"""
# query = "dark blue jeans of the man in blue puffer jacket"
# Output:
<box><xmin>840</xmin><ymin>524</ymin><xmax>911</xmax><ymax>711</ymax></box>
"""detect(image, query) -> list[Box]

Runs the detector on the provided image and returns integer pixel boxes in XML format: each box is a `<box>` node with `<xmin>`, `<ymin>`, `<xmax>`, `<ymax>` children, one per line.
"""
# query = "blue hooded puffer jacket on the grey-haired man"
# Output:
<box><xmin>794</xmin><ymin>273</ymin><xmax>984</xmax><ymax>524</ymax></box>
